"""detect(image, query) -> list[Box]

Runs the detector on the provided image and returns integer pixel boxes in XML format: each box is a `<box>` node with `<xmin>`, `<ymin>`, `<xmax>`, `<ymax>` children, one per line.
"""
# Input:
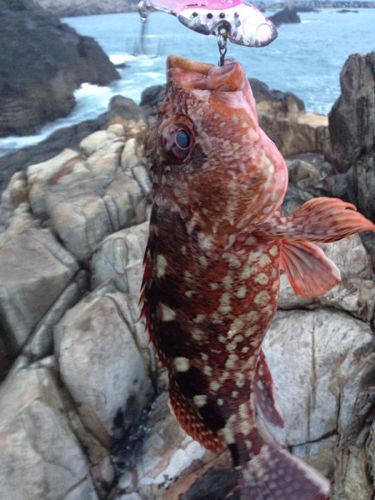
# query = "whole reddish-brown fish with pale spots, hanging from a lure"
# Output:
<box><xmin>141</xmin><ymin>56</ymin><xmax>375</xmax><ymax>500</ymax></box>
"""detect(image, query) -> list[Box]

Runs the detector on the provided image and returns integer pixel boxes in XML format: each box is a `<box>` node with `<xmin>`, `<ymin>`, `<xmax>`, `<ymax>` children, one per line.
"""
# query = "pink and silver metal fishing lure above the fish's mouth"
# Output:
<box><xmin>139</xmin><ymin>0</ymin><xmax>277</xmax><ymax>47</ymax></box>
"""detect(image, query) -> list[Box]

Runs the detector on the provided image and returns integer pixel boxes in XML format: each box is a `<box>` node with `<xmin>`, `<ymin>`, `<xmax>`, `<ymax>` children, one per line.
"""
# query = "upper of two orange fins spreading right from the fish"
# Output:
<box><xmin>256</xmin><ymin>197</ymin><xmax>375</xmax><ymax>243</ymax></box>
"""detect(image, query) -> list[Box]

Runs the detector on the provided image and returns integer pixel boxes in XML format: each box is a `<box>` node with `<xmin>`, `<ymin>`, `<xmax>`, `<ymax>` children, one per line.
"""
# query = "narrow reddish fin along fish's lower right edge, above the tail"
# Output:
<box><xmin>254</xmin><ymin>351</ymin><xmax>284</xmax><ymax>427</ymax></box>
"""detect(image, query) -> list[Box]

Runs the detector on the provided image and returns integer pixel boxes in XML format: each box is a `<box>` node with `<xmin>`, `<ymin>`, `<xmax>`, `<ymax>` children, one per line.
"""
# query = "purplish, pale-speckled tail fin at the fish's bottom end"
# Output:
<box><xmin>229</xmin><ymin>428</ymin><xmax>330</xmax><ymax>500</ymax></box>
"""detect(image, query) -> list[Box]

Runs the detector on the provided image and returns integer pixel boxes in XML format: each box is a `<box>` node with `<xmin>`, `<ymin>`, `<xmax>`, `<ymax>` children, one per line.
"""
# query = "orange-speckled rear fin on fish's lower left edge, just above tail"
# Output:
<box><xmin>169</xmin><ymin>377</ymin><xmax>224</xmax><ymax>452</ymax></box>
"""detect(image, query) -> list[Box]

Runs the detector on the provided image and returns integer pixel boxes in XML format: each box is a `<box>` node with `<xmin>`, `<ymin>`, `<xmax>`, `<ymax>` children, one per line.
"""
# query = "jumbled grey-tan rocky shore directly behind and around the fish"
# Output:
<box><xmin>0</xmin><ymin>53</ymin><xmax>375</xmax><ymax>500</ymax></box>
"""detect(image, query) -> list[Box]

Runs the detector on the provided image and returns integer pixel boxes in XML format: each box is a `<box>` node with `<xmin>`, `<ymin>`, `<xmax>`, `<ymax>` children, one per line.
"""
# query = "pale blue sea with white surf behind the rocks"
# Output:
<box><xmin>0</xmin><ymin>9</ymin><xmax>375</xmax><ymax>156</ymax></box>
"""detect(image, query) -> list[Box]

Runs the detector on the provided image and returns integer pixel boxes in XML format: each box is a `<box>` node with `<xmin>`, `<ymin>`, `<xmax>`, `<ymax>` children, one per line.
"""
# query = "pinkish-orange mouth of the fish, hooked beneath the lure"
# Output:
<box><xmin>167</xmin><ymin>56</ymin><xmax>247</xmax><ymax>92</ymax></box>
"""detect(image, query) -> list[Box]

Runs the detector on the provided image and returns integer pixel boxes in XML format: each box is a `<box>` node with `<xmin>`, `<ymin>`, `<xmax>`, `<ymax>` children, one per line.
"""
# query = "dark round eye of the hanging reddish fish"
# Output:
<box><xmin>160</xmin><ymin>123</ymin><xmax>194</xmax><ymax>164</ymax></box>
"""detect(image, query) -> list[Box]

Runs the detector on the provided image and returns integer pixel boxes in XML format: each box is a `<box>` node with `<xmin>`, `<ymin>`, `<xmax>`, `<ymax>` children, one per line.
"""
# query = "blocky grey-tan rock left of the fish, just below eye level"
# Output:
<box><xmin>46</xmin><ymin>168</ymin><xmax>148</xmax><ymax>261</ymax></box>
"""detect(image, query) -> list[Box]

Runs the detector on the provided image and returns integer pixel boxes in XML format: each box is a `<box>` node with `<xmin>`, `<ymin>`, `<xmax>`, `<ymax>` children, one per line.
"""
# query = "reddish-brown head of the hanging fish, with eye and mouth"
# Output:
<box><xmin>149</xmin><ymin>56</ymin><xmax>285</xmax><ymax>239</ymax></box>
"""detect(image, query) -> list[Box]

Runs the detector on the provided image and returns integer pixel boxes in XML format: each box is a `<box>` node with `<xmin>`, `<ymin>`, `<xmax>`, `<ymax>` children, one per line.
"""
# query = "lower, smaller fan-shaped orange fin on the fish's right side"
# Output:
<box><xmin>280</xmin><ymin>240</ymin><xmax>340</xmax><ymax>297</ymax></box>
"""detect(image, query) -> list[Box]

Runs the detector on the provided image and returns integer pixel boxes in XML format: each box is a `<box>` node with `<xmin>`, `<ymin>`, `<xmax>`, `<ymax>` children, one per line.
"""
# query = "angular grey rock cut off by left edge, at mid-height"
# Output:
<box><xmin>0</xmin><ymin>219</ymin><xmax>78</xmax><ymax>356</ymax></box>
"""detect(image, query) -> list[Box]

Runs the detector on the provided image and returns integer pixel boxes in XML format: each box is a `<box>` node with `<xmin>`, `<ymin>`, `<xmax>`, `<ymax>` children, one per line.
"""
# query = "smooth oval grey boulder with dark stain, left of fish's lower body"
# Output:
<box><xmin>55</xmin><ymin>286</ymin><xmax>152</xmax><ymax>439</ymax></box>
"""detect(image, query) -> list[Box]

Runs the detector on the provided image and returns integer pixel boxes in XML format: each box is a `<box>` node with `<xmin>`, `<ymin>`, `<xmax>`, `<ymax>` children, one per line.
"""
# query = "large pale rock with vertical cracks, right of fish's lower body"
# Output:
<box><xmin>264</xmin><ymin>309</ymin><xmax>374</xmax><ymax>480</ymax></box>
